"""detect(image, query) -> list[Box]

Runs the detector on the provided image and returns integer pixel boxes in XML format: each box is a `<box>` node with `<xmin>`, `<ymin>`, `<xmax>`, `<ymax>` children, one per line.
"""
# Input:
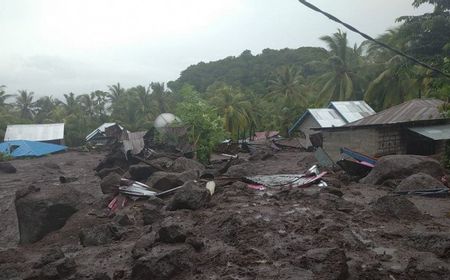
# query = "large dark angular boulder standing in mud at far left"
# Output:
<box><xmin>15</xmin><ymin>186</ymin><xmax>87</xmax><ymax>244</ymax></box>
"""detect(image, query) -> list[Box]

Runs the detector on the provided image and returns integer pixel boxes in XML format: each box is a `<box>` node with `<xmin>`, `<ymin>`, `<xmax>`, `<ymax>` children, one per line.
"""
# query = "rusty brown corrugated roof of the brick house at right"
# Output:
<box><xmin>346</xmin><ymin>99</ymin><xmax>445</xmax><ymax>127</ymax></box>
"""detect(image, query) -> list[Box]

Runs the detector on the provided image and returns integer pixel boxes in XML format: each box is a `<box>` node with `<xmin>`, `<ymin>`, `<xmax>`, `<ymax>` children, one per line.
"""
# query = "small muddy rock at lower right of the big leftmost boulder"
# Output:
<box><xmin>79</xmin><ymin>224</ymin><xmax>123</xmax><ymax>246</ymax></box>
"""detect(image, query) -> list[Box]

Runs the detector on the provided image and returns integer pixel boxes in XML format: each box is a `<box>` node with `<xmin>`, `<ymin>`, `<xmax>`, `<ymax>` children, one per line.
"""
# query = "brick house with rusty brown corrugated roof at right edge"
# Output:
<box><xmin>315</xmin><ymin>99</ymin><xmax>450</xmax><ymax>160</ymax></box>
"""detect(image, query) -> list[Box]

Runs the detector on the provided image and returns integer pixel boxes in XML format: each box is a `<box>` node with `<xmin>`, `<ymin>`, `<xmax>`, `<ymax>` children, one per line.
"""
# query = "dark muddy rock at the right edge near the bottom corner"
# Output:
<box><xmin>406</xmin><ymin>232</ymin><xmax>450</xmax><ymax>259</ymax></box>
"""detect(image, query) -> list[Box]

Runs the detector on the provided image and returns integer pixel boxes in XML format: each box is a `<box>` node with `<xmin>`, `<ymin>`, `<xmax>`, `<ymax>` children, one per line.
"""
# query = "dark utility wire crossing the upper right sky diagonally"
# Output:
<box><xmin>298</xmin><ymin>0</ymin><xmax>450</xmax><ymax>78</ymax></box>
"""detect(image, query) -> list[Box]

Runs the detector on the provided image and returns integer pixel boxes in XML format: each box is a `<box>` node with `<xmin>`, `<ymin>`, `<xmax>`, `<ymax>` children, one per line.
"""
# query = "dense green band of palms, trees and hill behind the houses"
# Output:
<box><xmin>0</xmin><ymin>0</ymin><xmax>450</xmax><ymax>160</ymax></box>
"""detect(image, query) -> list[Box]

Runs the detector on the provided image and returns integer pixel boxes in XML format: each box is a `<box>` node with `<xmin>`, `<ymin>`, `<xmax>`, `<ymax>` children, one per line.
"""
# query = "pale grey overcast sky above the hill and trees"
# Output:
<box><xmin>0</xmin><ymin>0</ymin><xmax>430</xmax><ymax>97</ymax></box>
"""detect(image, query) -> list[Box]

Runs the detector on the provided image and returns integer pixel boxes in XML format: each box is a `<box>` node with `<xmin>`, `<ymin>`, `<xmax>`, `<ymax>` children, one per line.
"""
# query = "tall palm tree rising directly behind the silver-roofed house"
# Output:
<box><xmin>318</xmin><ymin>30</ymin><xmax>363</xmax><ymax>104</ymax></box>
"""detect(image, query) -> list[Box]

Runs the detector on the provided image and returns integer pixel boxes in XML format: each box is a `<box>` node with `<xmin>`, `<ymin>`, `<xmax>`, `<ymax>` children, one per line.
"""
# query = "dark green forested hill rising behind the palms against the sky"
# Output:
<box><xmin>168</xmin><ymin>47</ymin><xmax>328</xmax><ymax>94</ymax></box>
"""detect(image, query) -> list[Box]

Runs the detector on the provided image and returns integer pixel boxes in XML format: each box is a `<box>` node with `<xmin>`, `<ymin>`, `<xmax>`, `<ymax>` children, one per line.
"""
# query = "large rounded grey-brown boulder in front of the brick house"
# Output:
<box><xmin>360</xmin><ymin>155</ymin><xmax>445</xmax><ymax>185</ymax></box>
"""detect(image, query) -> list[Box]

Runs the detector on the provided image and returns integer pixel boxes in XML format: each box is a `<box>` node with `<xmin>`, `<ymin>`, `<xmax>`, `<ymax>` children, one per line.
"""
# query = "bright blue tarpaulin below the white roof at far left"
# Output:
<box><xmin>0</xmin><ymin>140</ymin><xmax>67</xmax><ymax>158</ymax></box>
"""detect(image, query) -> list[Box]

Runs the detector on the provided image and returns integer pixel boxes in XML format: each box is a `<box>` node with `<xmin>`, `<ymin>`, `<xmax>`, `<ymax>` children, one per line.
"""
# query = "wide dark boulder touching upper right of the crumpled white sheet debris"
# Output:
<box><xmin>146</xmin><ymin>170</ymin><xmax>199</xmax><ymax>191</ymax></box>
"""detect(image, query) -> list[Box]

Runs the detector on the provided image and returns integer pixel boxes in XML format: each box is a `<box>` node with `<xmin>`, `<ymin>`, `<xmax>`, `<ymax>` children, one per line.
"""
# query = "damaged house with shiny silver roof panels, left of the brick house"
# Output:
<box><xmin>288</xmin><ymin>101</ymin><xmax>375</xmax><ymax>148</ymax></box>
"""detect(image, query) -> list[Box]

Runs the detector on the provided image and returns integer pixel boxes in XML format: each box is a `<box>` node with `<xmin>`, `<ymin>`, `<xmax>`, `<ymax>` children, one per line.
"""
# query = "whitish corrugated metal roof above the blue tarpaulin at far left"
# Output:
<box><xmin>5</xmin><ymin>123</ymin><xmax>64</xmax><ymax>141</ymax></box>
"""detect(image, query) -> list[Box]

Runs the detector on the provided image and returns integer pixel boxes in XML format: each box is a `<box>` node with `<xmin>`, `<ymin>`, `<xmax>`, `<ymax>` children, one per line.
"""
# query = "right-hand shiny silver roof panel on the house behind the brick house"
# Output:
<box><xmin>328</xmin><ymin>101</ymin><xmax>375</xmax><ymax>122</ymax></box>
